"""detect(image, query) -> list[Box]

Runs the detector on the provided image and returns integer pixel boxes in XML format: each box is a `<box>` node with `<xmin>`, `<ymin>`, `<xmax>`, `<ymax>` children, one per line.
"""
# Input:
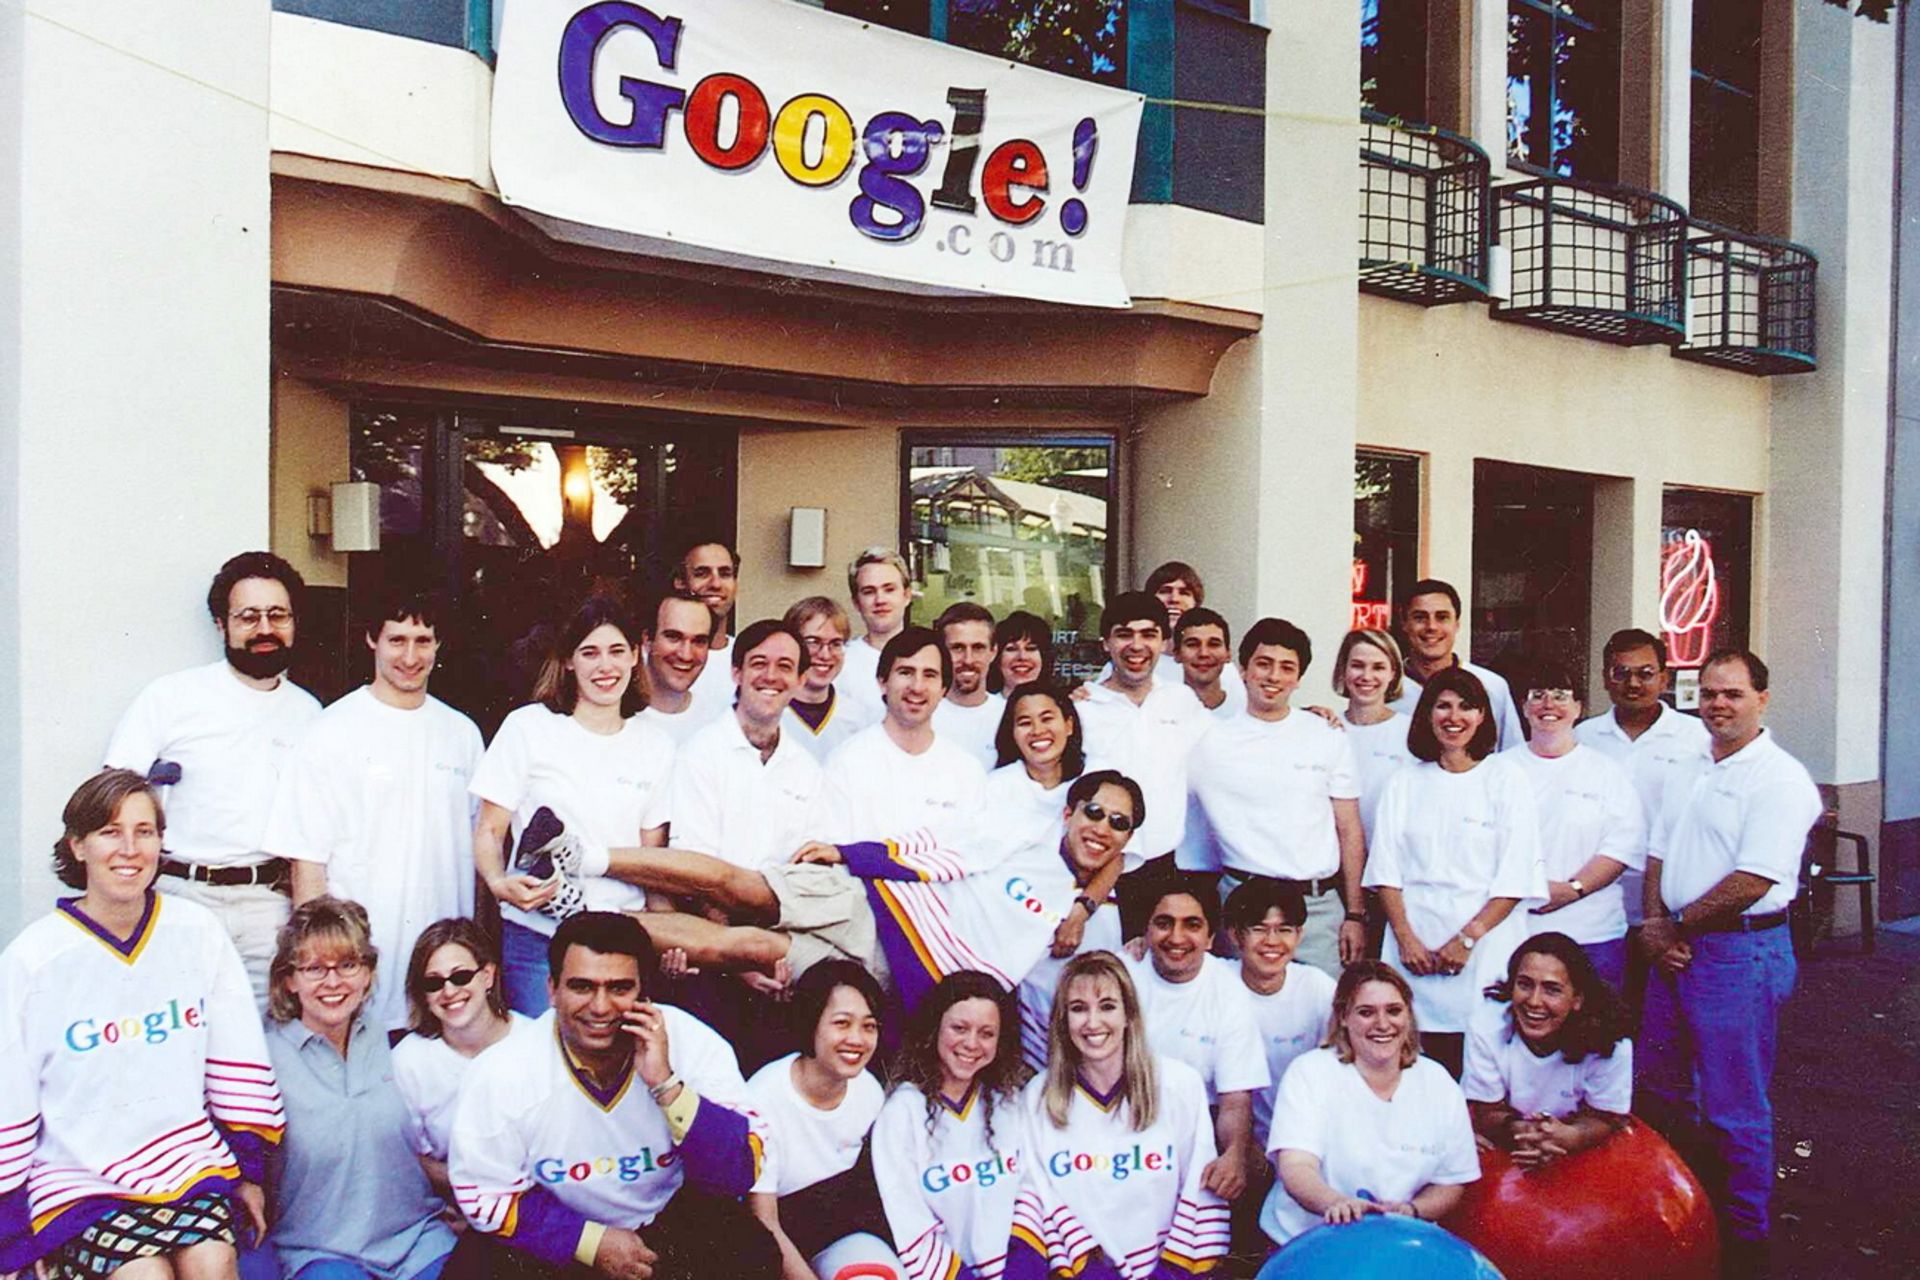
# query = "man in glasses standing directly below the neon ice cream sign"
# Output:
<box><xmin>1572</xmin><ymin>628</ymin><xmax>1707</xmax><ymax>948</ymax></box>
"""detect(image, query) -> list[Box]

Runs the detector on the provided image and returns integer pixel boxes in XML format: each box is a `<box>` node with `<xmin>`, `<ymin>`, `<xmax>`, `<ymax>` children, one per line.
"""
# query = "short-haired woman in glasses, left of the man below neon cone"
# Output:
<box><xmin>1501</xmin><ymin>666</ymin><xmax>1647</xmax><ymax>990</ymax></box>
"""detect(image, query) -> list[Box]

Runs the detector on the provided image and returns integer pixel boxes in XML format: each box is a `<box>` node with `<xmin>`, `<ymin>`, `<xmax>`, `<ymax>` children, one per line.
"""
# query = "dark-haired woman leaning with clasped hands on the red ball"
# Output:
<box><xmin>1461</xmin><ymin>933</ymin><xmax>1634</xmax><ymax>1167</ymax></box>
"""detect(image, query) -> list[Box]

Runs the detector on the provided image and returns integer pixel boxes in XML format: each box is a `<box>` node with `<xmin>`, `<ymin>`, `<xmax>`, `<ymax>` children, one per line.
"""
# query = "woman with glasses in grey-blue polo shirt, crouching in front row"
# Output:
<box><xmin>267</xmin><ymin>896</ymin><xmax>455</xmax><ymax>1280</ymax></box>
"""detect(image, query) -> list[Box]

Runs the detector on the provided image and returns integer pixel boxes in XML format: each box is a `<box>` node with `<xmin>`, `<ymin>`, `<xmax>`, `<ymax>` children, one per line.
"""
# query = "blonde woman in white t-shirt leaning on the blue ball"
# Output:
<box><xmin>1260</xmin><ymin>960</ymin><xmax>1480</xmax><ymax>1245</ymax></box>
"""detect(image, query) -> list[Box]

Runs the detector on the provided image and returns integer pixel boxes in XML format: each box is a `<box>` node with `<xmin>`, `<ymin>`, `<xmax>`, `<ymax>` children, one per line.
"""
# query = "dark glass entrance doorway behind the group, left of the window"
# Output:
<box><xmin>338</xmin><ymin>405</ymin><xmax>737</xmax><ymax>737</ymax></box>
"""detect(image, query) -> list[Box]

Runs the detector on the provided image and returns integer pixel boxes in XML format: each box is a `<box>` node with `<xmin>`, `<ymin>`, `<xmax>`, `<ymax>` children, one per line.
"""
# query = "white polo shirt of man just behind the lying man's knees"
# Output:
<box><xmin>672</xmin><ymin>714</ymin><xmax>828</xmax><ymax>871</ymax></box>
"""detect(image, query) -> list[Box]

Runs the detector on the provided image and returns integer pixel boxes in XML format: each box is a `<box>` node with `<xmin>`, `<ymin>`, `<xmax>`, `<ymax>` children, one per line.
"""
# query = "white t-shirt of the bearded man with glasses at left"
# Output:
<box><xmin>106</xmin><ymin>658</ymin><xmax>321</xmax><ymax>867</ymax></box>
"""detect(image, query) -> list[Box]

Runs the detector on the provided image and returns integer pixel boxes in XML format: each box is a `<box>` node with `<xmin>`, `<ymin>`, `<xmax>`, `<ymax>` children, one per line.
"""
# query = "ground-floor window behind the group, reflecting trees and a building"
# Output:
<box><xmin>900</xmin><ymin>434</ymin><xmax>1116</xmax><ymax>679</ymax></box>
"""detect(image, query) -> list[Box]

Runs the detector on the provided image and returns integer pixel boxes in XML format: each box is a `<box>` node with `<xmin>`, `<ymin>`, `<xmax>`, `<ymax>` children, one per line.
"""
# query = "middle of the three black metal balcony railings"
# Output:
<box><xmin>1494</xmin><ymin>178</ymin><xmax>1688</xmax><ymax>345</ymax></box>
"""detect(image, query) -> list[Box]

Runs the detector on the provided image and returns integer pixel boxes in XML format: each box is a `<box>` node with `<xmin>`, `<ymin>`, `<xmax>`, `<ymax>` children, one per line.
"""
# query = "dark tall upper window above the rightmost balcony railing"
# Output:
<box><xmin>1690</xmin><ymin>0</ymin><xmax>1761</xmax><ymax>230</ymax></box>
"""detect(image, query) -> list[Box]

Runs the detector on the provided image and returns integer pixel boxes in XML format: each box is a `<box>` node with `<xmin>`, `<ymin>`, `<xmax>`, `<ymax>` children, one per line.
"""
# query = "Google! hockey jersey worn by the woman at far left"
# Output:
<box><xmin>0</xmin><ymin>892</ymin><xmax>286</xmax><ymax>1272</ymax></box>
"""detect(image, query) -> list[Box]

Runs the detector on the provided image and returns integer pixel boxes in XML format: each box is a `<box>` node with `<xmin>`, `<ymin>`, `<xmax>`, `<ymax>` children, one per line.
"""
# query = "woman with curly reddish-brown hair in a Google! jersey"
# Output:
<box><xmin>874</xmin><ymin>969</ymin><xmax>1027</xmax><ymax>1280</ymax></box>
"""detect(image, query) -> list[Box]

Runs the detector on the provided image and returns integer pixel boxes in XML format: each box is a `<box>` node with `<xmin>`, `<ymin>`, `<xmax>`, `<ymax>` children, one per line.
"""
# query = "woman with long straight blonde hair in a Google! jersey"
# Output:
<box><xmin>1004</xmin><ymin>952</ymin><xmax>1229</xmax><ymax>1280</ymax></box>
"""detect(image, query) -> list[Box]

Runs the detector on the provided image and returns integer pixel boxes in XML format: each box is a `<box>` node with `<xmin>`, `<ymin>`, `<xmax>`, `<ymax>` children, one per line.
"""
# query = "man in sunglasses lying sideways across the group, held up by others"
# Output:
<box><xmin>518</xmin><ymin>770</ymin><xmax>1146</xmax><ymax>1011</ymax></box>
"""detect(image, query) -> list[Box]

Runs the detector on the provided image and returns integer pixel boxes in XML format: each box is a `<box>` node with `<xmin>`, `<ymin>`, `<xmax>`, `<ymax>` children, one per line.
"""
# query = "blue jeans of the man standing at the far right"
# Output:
<box><xmin>1634</xmin><ymin>927</ymin><xmax>1797</xmax><ymax>1240</ymax></box>
